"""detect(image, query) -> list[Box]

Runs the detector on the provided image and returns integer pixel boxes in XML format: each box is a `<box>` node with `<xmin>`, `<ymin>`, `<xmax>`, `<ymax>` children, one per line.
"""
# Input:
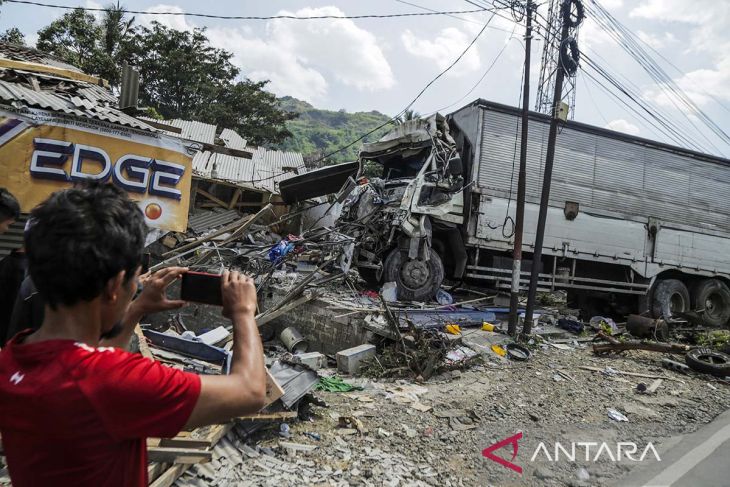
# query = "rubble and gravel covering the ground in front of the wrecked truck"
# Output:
<box><xmin>112</xmin><ymin>165</ymin><xmax>730</xmax><ymax>486</ymax></box>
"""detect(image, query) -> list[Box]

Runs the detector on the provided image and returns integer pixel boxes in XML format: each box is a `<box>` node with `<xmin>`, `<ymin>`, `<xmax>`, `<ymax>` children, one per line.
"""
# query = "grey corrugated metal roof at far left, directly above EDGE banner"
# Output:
<box><xmin>0</xmin><ymin>80</ymin><xmax>157</xmax><ymax>132</ymax></box>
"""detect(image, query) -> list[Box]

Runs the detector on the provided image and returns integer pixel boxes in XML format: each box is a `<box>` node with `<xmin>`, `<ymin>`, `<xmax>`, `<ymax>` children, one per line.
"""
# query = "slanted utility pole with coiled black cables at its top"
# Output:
<box><xmin>522</xmin><ymin>2</ymin><xmax>570</xmax><ymax>335</ymax></box>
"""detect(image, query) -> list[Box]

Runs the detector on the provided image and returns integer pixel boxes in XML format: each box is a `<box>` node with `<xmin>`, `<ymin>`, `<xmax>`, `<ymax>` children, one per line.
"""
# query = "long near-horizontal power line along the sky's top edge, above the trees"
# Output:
<box><xmin>5</xmin><ymin>0</ymin><xmax>489</xmax><ymax>20</ymax></box>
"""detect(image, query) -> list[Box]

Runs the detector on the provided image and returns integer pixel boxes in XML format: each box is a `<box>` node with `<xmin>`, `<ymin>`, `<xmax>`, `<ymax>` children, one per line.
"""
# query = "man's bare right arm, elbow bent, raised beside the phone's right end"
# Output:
<box><xmin>185</xmin><ymin>271</ymin><xmax>266</xmax><ymax>429</ymax></box>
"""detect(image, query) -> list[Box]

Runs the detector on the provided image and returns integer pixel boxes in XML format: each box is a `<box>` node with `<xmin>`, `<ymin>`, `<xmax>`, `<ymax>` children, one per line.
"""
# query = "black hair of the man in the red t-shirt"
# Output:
<box><xmin>25</xmin><ymin>183</ymin><xmax>147</xmax><ymax>309</ymax></box>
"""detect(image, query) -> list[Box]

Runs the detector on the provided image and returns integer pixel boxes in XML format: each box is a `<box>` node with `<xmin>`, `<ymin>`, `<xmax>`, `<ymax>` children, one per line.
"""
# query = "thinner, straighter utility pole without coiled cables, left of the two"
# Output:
<box><xmin>507</xmin><ymin>0</ymin><xmax>534</xmax><ymax>336</ymax></box>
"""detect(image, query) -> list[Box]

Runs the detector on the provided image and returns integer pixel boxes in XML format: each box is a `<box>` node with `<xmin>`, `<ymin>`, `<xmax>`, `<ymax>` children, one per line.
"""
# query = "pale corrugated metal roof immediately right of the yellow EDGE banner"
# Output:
<box><xmin>193</xmin><ymin>147</ymin><xmax>306</xmax><ymax>193</ymax></box>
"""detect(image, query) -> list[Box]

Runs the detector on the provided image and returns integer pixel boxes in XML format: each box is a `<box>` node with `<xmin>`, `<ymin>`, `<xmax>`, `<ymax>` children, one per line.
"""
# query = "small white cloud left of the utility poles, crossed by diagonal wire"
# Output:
<box><xmin>401</xmin><ymin>27</ymin><xmax>481</xmax><ymax>76</ymax></box>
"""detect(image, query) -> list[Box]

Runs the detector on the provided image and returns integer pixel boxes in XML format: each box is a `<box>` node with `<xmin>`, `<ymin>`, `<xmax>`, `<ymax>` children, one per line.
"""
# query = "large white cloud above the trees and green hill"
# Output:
<box><xmin>132</xmin><ymin>4</ymin><xmax>395</xmax><ymax>102</ymax></box>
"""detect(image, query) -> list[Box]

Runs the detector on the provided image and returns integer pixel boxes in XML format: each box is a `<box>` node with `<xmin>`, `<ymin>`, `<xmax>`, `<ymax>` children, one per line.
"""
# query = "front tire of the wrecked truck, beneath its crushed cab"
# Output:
<box><xmin>383</xmin><ymin>248</ymin><xmax>444</xmax><ymax>301</ymax></box>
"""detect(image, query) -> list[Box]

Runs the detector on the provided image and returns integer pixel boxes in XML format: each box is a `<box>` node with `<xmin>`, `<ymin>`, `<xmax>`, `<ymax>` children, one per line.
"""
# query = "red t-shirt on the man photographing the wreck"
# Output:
<box><xmin>0</xmin><ymin>331</ymin><xmax>200</xmax><ymax>487</ymax></box>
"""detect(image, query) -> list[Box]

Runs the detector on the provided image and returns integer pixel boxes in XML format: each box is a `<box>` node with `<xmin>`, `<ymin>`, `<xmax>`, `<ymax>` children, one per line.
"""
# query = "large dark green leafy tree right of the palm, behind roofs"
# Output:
<box><xmin>129</xmin><ymin>22</ymin><xmax>296</xmax><ymax>145</ymax></box>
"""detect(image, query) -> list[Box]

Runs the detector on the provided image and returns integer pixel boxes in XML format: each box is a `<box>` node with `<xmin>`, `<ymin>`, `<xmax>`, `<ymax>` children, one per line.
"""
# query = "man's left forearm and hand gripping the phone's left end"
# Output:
<box><xmin>99</xmin><ymin>267</ymin><xmax>188</xmax><ymax>350</ymax></box>
